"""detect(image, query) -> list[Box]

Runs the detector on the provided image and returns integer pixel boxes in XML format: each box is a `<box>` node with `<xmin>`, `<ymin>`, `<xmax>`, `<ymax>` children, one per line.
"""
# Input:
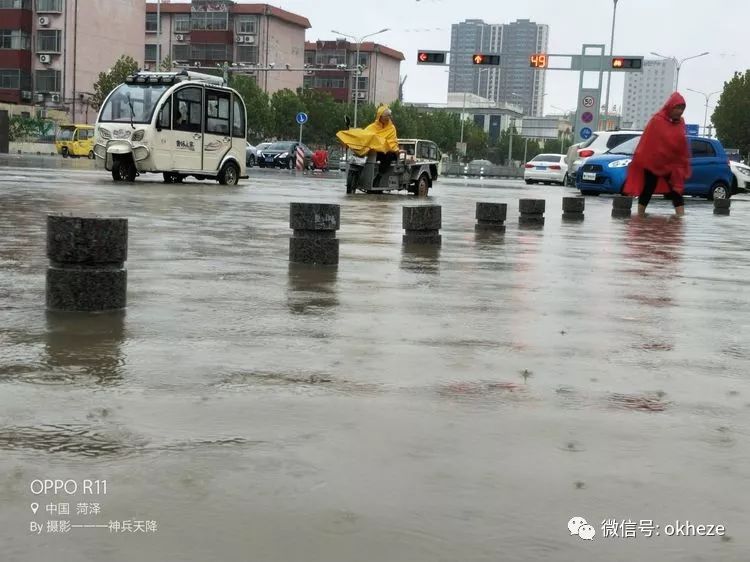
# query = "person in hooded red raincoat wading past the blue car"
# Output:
<box><xmin>623</xmin><ymin>92</ymin><xmax>690</xmax><ymax>216</ymax></box>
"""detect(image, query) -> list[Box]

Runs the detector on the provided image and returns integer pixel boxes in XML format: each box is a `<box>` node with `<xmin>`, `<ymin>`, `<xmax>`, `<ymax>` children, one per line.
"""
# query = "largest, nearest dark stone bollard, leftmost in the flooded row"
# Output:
<box><xmin>47</xmin><ymin>215</ymin><xmax>128</xmax><ymax>312</ymax></box>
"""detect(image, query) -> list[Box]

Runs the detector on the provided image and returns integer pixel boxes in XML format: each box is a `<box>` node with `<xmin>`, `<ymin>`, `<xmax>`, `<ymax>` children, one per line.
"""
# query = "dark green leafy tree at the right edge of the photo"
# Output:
<box><xmin>711</xmin><ymin>70</ymin><xmax>750</xmax><ymax>158</ymax></box>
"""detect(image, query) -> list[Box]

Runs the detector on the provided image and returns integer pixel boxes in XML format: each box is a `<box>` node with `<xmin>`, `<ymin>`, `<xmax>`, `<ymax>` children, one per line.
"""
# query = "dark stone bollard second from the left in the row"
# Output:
<box><xmin>289</xmin><ymin>203</ymin><xmax>341</xmax><ymax>265</ymax></box>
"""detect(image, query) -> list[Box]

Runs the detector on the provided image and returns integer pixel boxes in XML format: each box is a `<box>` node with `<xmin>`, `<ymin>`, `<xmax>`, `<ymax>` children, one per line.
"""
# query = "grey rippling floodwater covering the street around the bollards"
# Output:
<box><xmin>0</xmin><ymin>154</ymin><xmax>750</xmax><ymax>562</ymax></box>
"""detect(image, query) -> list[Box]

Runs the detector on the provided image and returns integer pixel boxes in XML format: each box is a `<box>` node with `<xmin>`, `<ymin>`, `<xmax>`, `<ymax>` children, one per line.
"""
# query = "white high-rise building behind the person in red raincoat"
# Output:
<box><xmin>622</xmin><ymin>59</ymin><xmax>677</xmax><ymax>129</ymax></box>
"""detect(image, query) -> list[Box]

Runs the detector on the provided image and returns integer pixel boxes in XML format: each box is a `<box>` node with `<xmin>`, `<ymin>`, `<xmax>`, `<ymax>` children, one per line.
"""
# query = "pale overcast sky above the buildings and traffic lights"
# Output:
<box><xmin>272</xmin><ymin>0</ymin><xmax>750</xmax><ymax>124</ymax></box>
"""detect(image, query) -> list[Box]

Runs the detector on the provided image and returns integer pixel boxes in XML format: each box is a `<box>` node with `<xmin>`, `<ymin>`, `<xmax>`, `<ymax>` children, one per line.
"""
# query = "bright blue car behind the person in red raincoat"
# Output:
<box><xmin>576</xmin><ymin>136</ymin><xmax>733</xmax><ymax>199</ymax></box>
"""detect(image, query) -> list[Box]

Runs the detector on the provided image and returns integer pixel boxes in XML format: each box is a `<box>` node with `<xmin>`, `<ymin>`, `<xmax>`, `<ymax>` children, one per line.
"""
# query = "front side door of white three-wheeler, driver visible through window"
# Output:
<box><xmin>169</xmin><ymin>86</ymin><xmax>203</xmax><ymax>172</ymax></box>
